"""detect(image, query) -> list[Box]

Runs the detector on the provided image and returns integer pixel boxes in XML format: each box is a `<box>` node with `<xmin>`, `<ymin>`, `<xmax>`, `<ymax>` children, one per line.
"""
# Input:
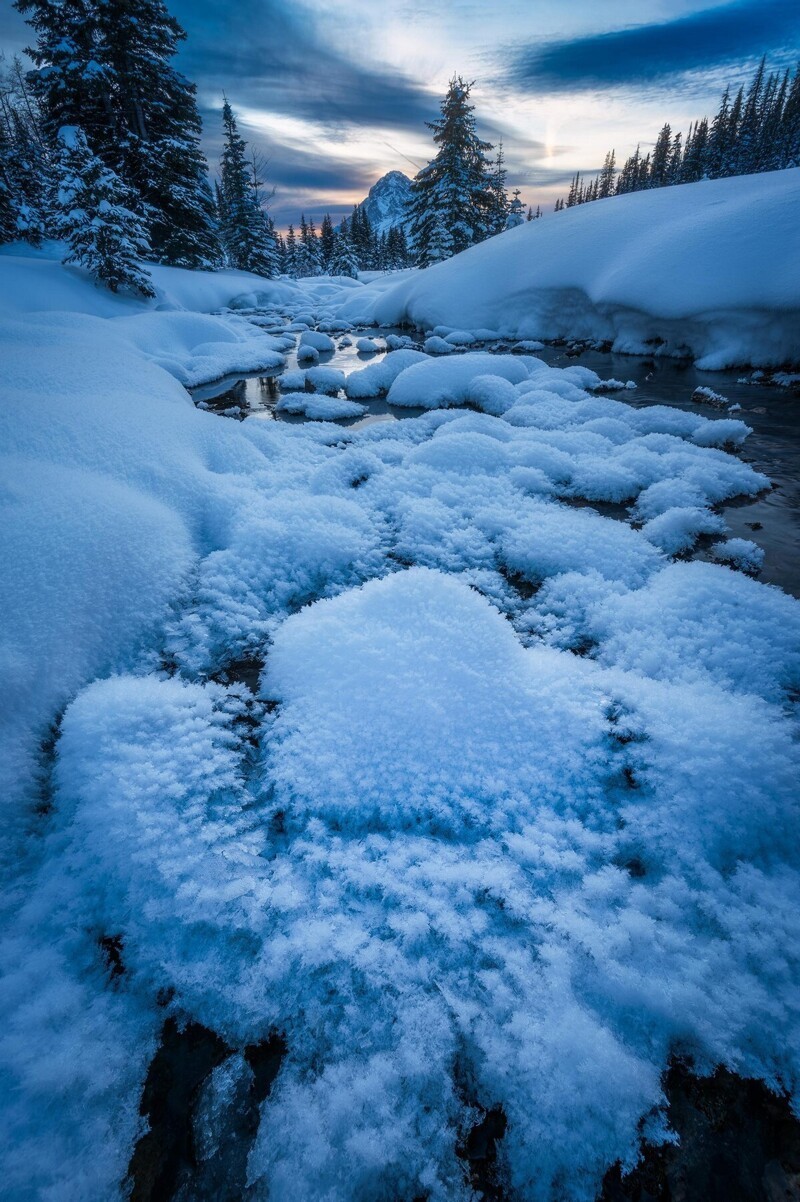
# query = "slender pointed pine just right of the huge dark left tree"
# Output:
<box><xmin>220</xmin><ymin>97</ymin><xmax>277</xmax><ymax>278</ymax></box>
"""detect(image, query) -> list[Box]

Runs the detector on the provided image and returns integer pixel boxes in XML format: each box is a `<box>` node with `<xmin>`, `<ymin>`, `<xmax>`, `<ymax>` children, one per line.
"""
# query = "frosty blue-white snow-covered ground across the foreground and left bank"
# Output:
<box><xmin>0</xmin><ymin>236</ymin><xmax>800</xmax><ymax>1202</ymax></box>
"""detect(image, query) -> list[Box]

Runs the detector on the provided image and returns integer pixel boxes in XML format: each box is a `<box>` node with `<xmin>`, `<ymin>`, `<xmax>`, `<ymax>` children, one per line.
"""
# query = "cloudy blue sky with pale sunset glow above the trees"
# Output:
<box><xmin>0</xmin><ymin>0</ymin><xmax>800</xmax><ymax>227</ymax></box>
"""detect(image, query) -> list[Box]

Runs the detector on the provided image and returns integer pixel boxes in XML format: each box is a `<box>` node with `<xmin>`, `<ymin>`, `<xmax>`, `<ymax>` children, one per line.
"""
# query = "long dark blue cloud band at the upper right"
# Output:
<box><xmin>509</xmin><ymin>0</ymin><xmax>800</xmax><ymax>91</ymax></box>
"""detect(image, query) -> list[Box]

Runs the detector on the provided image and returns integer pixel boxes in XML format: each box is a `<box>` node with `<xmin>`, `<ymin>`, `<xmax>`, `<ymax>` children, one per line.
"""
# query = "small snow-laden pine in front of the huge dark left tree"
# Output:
<box><xmin>54</xmin><ymin>125</ymin><xmax>155</xmax><ymax>297</ymax></box>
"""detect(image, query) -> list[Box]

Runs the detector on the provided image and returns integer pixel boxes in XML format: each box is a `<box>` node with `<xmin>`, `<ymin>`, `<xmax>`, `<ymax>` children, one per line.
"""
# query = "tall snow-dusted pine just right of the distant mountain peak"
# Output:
<box><xmin>408</xmin><ymin>76</ymin><xmax>491</xmax><ymax>267</ymax></box>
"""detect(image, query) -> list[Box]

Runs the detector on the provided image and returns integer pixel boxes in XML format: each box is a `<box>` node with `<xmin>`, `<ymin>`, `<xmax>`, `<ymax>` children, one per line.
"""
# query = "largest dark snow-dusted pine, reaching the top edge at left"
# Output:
<box><xmin>17</xmin><ymin>0</ymin><xmax>220</xmax><ymax>267</ymax></box>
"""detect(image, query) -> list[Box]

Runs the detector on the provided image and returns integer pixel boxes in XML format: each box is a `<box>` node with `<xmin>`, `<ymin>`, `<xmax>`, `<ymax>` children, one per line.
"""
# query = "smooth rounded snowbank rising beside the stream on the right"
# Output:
<box><xmin>341</xmin><ymin>168</ymin><xmax>800</xmax><ymax>368</ymax></box>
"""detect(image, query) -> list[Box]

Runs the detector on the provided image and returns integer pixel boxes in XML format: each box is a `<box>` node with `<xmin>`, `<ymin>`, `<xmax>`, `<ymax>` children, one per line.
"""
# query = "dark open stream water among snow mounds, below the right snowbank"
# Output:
<box><xmin>192</xmin><ymin>329</ymin><xmax>800</xmax><ymax>596</ymax></box>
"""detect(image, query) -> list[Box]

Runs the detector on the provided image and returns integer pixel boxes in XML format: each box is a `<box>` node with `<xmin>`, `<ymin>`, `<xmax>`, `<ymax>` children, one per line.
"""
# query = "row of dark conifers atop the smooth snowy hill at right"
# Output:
<box><xmin>555</xmin><ymin>59</ymin><xmax>800</xmax><ymax>212</ymax></box>
